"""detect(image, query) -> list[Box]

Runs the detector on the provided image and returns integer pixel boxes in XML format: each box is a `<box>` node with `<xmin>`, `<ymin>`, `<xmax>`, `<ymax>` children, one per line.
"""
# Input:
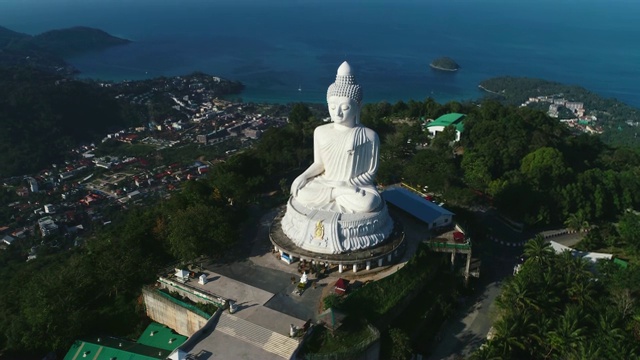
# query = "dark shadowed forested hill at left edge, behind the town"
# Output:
<box><xmin>0</xmin><ymin>67</ymin><xmax>146</xmax><ymax>177</ymax></box>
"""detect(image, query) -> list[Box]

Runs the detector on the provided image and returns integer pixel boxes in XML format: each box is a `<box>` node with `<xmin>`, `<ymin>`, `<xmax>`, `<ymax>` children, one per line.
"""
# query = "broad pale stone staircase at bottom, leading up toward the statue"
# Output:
<box><xmin>214</xmin><ymin>312</ymin><xmax>299</xmax><ymax>359</ymax></box>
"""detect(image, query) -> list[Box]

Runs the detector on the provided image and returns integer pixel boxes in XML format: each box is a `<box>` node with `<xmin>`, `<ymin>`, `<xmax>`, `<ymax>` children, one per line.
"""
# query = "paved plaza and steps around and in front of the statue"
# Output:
<box><xmin>190</xmin><ymin>205</ymin><xmax>440</xmax><ymax>359</ymax></box>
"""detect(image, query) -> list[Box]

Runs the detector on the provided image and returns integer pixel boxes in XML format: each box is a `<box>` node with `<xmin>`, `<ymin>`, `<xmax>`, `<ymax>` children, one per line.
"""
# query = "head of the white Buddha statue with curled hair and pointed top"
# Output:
<box><xmin>327</xmin><ymin>61</ymin><xmax>362</xmax><ymax>127</ymax></box>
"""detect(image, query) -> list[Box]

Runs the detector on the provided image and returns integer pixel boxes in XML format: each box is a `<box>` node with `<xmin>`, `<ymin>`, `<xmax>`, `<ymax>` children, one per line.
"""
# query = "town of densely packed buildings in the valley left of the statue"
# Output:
<box><xmin>0</xmin><ymin>75</ymin><xmax>287</xmax><ymax>261</ymax></box>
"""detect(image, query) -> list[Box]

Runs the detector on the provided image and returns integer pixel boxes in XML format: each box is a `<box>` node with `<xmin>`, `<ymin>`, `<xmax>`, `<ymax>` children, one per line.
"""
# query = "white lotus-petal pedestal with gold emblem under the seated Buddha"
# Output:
<box><xmin>281</xmin><ymin>197</ymin><xmax>393</xmax><ymax>254</ymax></box>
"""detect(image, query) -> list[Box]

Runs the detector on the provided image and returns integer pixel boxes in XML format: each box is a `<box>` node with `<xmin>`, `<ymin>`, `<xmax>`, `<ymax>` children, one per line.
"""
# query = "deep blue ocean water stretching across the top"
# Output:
<box><xmin>0</xmin><ymin>0</ymin><xmax>640</xmax><ymax>107</ymax></box>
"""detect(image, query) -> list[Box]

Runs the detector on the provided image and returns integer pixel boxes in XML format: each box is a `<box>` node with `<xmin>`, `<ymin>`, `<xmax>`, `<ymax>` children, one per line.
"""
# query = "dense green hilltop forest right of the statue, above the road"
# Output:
<box><xmin>362</xmin><ymin>99</ymin><xmax>640</xmax><ymax>228</ymax></box>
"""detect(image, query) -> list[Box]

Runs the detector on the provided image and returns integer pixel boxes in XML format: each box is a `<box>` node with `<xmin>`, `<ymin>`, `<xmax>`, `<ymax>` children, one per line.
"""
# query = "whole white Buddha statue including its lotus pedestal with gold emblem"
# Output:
<box><xmin>281</xmin><ymin>61</ymin><xmax>393</xmax><ymax>254</ymax></box>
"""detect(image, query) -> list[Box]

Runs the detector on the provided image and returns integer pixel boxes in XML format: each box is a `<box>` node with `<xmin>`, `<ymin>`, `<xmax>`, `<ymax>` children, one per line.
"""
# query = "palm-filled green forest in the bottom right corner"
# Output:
<box><xmin>472</xmin><ymin>237</ymin><xmax>640</xmax><ymax>360</ymax></box>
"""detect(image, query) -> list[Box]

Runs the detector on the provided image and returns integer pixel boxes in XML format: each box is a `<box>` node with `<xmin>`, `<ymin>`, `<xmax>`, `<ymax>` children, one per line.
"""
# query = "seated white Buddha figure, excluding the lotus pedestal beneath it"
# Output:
<box><xmin>291</xmin><ymin>61</ymin><xmax>381</xmax><ymax>213</ymax></box>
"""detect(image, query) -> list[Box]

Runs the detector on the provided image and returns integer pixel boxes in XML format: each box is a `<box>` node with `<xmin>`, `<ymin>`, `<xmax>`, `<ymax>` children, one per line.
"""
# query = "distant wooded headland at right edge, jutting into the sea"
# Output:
<box><xmin>480</xmin><ymin>76</ymin><xmax>640</xmax><ymax>146</ymax></box>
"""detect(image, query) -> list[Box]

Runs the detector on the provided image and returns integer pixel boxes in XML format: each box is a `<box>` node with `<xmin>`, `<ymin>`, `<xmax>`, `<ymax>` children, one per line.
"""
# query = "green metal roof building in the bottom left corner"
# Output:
<box><xmin>64</xmin><ymin>323</ymin><xmax>187</xmax><ymax>360</ymax></box>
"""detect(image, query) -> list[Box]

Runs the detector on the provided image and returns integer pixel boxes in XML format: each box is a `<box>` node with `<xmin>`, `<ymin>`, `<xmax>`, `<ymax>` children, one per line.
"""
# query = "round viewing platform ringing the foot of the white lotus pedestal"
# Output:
<box><xmin>269</xmin><ymin>207</ymin><xmax>406</xmax><ymax>271</ymax></box>
